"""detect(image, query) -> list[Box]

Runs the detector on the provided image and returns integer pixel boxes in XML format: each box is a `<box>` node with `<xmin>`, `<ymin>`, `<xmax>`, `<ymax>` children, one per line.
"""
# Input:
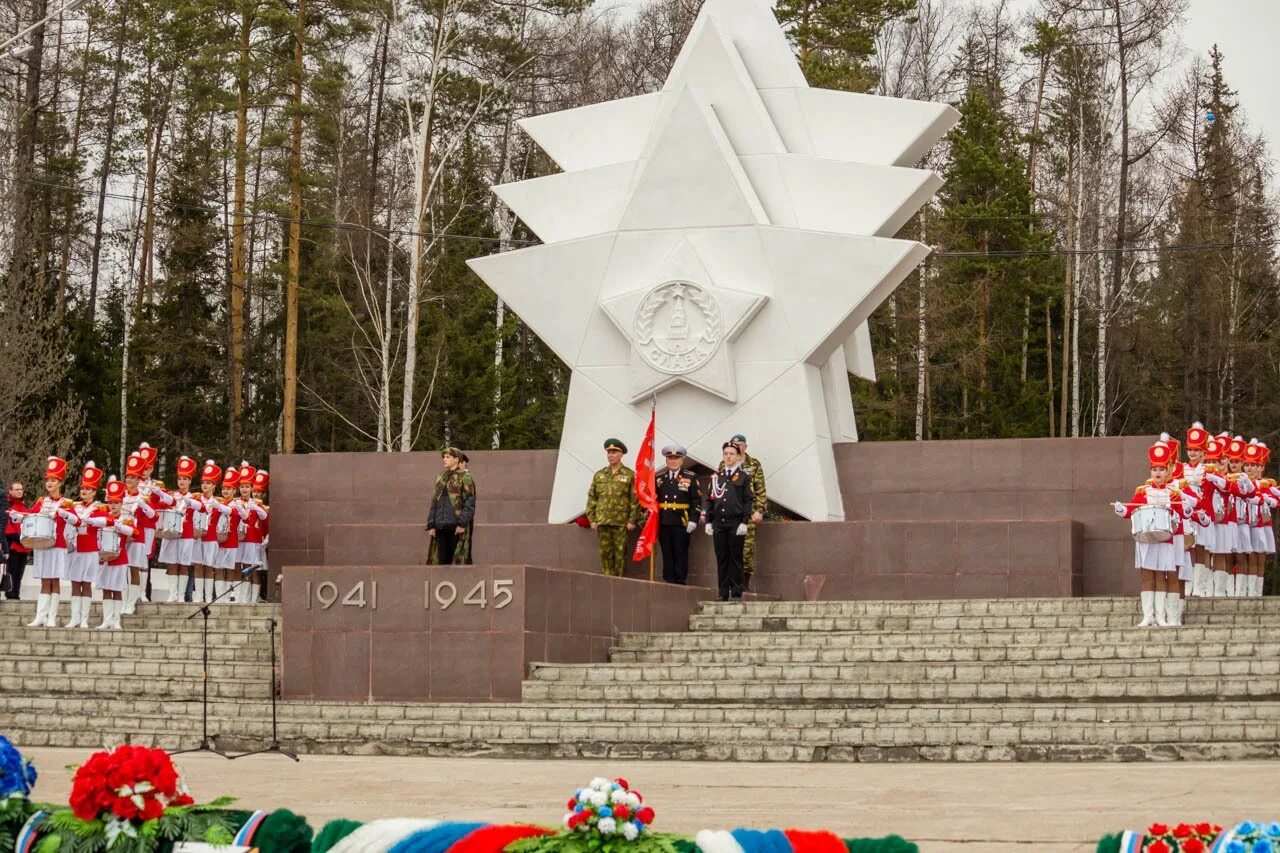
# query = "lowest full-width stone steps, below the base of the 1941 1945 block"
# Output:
<box><xmin>0</xmin><ymin>697</ymin><xmax>1280</xmax><ymax>761</ymax></box>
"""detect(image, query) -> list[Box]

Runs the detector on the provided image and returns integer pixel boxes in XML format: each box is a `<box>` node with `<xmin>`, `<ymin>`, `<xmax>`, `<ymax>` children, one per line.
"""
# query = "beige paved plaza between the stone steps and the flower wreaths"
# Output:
<box><xmin>24</xmin><ymin>748</ymin><xmax>1280</xmax><ymax>853</ymax></box>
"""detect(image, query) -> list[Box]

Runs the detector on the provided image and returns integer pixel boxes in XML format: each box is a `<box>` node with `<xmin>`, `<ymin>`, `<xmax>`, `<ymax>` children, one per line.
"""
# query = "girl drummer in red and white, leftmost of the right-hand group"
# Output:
<box><xmin>1114</xmin><ymin>442</ymin><xmax>1192</xmax><ymax>628</ymax></box>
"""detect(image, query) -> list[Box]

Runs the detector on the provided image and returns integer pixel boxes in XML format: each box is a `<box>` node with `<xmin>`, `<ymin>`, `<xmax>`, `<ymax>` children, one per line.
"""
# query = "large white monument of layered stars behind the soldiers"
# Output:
<box><xmin>470</xmin><ymin>0</ymin><xmax>957</xmax><ymax>523</ymax></box>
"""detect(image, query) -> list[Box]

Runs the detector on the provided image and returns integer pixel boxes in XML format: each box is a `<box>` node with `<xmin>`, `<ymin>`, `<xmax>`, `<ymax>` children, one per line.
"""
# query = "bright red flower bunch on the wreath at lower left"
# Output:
<box><xmin>70</xmin><ymin>745</ymin><xmax>195</xmax><ymax>821</ymax></box>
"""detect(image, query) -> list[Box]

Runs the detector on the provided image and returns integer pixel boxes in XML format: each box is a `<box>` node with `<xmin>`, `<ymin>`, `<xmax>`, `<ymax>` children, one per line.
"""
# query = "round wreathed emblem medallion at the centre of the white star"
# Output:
<box><xmin>635</xmin><ymin>280</ymin><xmax>724</xmax><ymax>375</ymax></box>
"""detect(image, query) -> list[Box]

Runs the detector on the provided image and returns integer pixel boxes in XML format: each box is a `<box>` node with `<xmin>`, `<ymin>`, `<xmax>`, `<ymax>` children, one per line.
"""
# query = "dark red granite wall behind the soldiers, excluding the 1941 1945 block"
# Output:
<box><xmin>271</xmin><ymin>437</ymin><xmax>1151</xmax><ymax>599</ymax></box>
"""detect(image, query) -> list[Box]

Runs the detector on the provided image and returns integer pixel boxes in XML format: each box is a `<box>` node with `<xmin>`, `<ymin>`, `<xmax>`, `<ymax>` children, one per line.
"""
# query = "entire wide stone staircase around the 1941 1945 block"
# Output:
<box><xmin>0</xmin><ymin>598</ymin><xmax>1280</xmax><ymax>761</ymax></box>
